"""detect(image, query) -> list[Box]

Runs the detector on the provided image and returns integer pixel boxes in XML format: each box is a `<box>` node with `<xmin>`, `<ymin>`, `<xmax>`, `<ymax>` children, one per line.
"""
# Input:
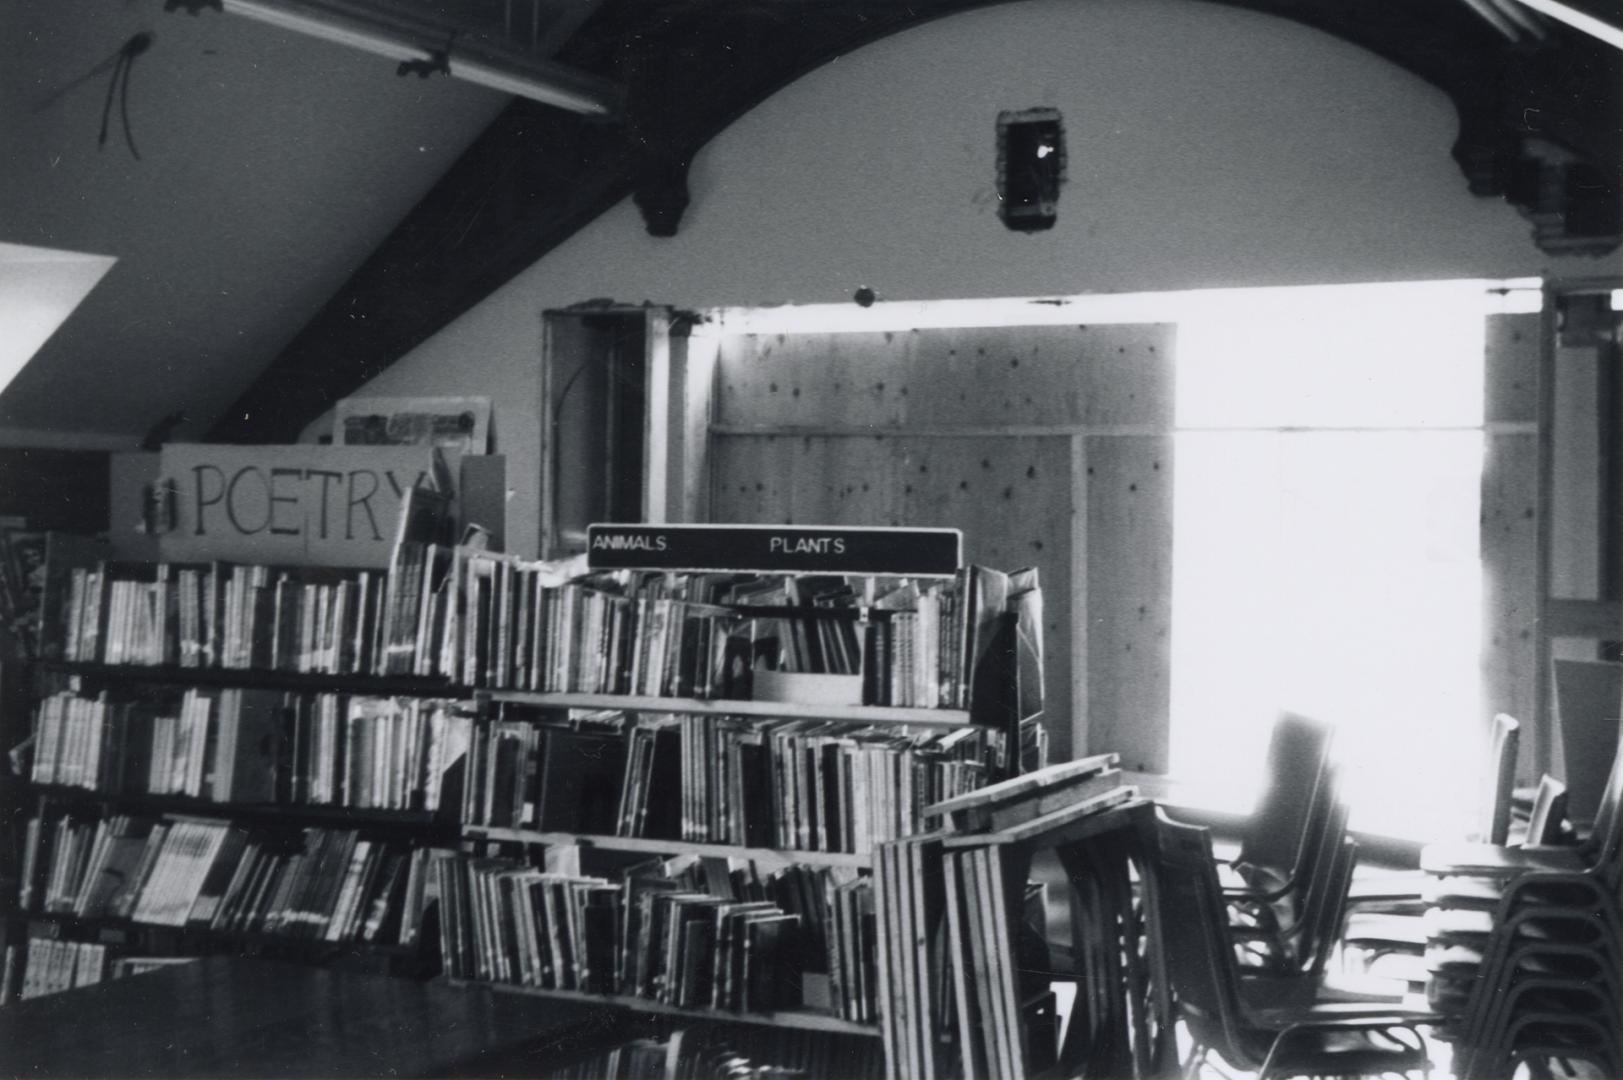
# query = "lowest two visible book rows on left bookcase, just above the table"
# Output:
<box><xmin>0</xmin><ymin>799</ymin><xmax>433</xmax><ymax>1000</ymax></box>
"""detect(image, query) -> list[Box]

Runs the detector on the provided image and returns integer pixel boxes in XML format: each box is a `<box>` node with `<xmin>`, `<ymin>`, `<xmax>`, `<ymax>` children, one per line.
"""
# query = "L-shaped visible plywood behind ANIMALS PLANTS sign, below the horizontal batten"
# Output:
<box><xmin>711</xmin><ymin>435</ymin><xmax>1071</xmax><ymax>758</ymax></box>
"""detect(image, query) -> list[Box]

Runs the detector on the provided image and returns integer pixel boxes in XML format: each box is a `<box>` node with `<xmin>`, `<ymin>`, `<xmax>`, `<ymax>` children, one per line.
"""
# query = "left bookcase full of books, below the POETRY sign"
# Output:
<box><xmin>3</xmin><ymin>534</ymin><xmax>474</xmax><ymax>999</ymax></box>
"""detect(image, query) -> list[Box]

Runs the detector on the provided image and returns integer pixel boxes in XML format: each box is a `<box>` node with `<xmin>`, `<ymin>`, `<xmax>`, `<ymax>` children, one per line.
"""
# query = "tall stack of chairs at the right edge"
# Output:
<box><xmin>1420</xmin><ymin>727</ymin><xmax>1623</xmax><ymax>1080</ymax></box>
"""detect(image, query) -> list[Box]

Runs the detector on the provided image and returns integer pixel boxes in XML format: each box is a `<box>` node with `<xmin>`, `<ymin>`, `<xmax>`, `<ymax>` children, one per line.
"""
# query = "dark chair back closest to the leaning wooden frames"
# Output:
<box><xmin>1154</xmin><ymin>809</ymin><xmax>1248</xmax><ymax>1067</ymax></box>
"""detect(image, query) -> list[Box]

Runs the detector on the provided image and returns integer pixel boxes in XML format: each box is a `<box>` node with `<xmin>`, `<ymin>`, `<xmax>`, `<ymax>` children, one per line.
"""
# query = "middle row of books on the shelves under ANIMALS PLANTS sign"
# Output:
<box><xmin>464</xmin><ymin>708</ymin><xmax>1003</xmax><ymax>854</ymax></box>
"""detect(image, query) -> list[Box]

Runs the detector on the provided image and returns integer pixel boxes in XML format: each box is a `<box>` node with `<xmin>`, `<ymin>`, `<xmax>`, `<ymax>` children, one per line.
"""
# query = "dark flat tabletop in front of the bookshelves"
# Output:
<box><xmin>0</xmin><ymin>957</ymin><xmax>625</xmax><ymax>1078</ymax></box>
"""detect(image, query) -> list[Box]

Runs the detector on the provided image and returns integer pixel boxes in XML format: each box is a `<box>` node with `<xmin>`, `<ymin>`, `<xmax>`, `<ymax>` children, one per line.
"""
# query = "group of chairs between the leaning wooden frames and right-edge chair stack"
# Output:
<box><xmin>1154</xmin><ymin>713</ymin><xmax>1435</xmax><ymax>1077</ymax></box>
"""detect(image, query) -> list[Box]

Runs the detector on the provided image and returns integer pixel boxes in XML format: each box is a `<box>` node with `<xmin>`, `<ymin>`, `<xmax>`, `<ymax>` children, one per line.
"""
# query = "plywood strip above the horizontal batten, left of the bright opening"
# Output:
<box><xmin>716</xmin><ymin>325</ymin><xmax>1173</xmax><ymax>430</ymax></box>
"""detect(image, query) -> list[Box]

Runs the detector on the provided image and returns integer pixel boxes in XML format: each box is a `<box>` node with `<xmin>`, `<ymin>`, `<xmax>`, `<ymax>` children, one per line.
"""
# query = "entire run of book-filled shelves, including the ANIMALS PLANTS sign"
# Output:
<box><xmin>3</xmin><ymin>526</ymin><xmax>1040</xmax><ymax>1078</ymax></box>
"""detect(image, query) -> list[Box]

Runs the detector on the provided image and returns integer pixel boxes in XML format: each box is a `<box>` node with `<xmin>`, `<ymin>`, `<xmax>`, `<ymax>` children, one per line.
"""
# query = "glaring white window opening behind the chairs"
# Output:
<box><xmin>1172</xmin><ymin>286</ymin><xmax>1485</xmax><ymax>835</ymax></box>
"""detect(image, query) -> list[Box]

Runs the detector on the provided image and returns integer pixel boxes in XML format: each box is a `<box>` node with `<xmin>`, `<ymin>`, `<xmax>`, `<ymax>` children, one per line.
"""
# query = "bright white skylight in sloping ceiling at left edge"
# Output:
<box><xmin>0</xmin><ymin>244</ymin><xmax>118</xmax><ymax>390</ymax></box>
